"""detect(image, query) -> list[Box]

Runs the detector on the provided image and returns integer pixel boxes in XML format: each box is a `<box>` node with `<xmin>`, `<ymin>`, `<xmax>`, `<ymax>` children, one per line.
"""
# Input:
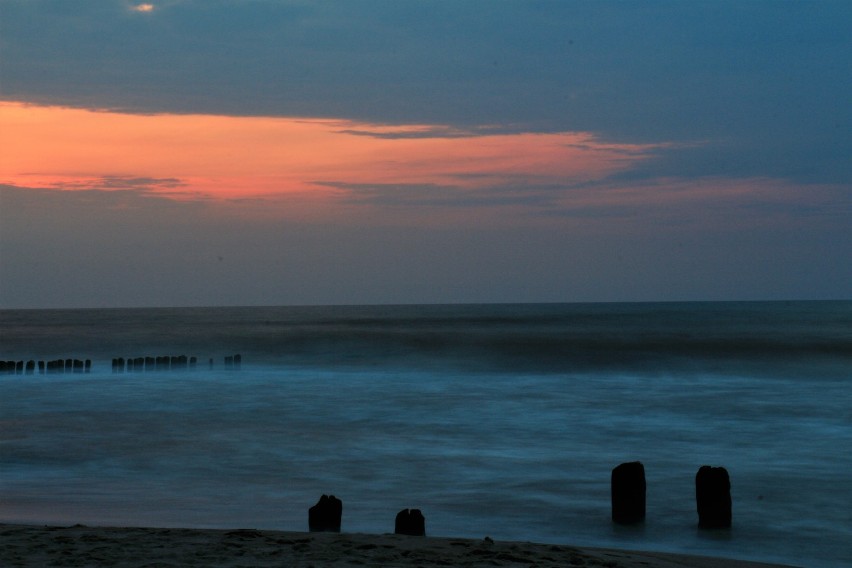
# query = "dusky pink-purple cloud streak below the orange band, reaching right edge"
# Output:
<box><xmin>315</xmin><ymin>176</ymin><xmax>852</xmax><ymax>237</ymax></box>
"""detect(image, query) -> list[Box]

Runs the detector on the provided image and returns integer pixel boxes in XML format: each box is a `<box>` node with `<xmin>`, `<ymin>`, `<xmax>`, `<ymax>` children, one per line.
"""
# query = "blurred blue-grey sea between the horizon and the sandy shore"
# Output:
<box><xmin>0</xmin><ymin>301</ymin><xmax>852</xmax><ymax>568</ymax></box>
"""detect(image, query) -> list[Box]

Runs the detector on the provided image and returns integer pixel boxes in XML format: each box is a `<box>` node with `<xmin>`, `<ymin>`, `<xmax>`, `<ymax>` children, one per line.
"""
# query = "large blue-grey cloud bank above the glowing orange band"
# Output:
<box><xmin>0</xmin><ymin>0</ymin><xmax>852</xmax><ymax>189</ymax></box>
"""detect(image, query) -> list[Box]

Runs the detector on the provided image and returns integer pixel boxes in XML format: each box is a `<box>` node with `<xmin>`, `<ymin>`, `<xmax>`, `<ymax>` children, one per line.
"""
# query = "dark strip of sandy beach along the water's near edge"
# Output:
<box><xmin>0</xmin><ymin>524</ymin><xmax>800</xmax><ymax>568</ymax></box>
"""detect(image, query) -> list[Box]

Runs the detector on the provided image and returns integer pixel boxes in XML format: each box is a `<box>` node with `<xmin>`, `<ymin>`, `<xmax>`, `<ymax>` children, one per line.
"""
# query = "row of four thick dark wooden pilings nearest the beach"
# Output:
<box><xmin>308</xmin><ymin>462</ymin><xmax>732</xmax><ymax>536</ymax></box>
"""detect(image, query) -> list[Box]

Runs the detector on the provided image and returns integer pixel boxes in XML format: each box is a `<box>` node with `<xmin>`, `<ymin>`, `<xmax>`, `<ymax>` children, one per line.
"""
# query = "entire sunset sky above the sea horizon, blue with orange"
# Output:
<box><xmin>0</xmin><ymin>0</ymin><xmax>852</xmax><ymax>308</ymax></box>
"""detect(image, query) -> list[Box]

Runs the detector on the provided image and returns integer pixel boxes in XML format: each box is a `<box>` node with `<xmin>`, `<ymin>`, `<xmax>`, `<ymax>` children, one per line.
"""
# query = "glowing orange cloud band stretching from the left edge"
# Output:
<box><xmin>0</xmin><ymin>102</ymin><xmax>659</xmax><ymax>209</ymax></box>
